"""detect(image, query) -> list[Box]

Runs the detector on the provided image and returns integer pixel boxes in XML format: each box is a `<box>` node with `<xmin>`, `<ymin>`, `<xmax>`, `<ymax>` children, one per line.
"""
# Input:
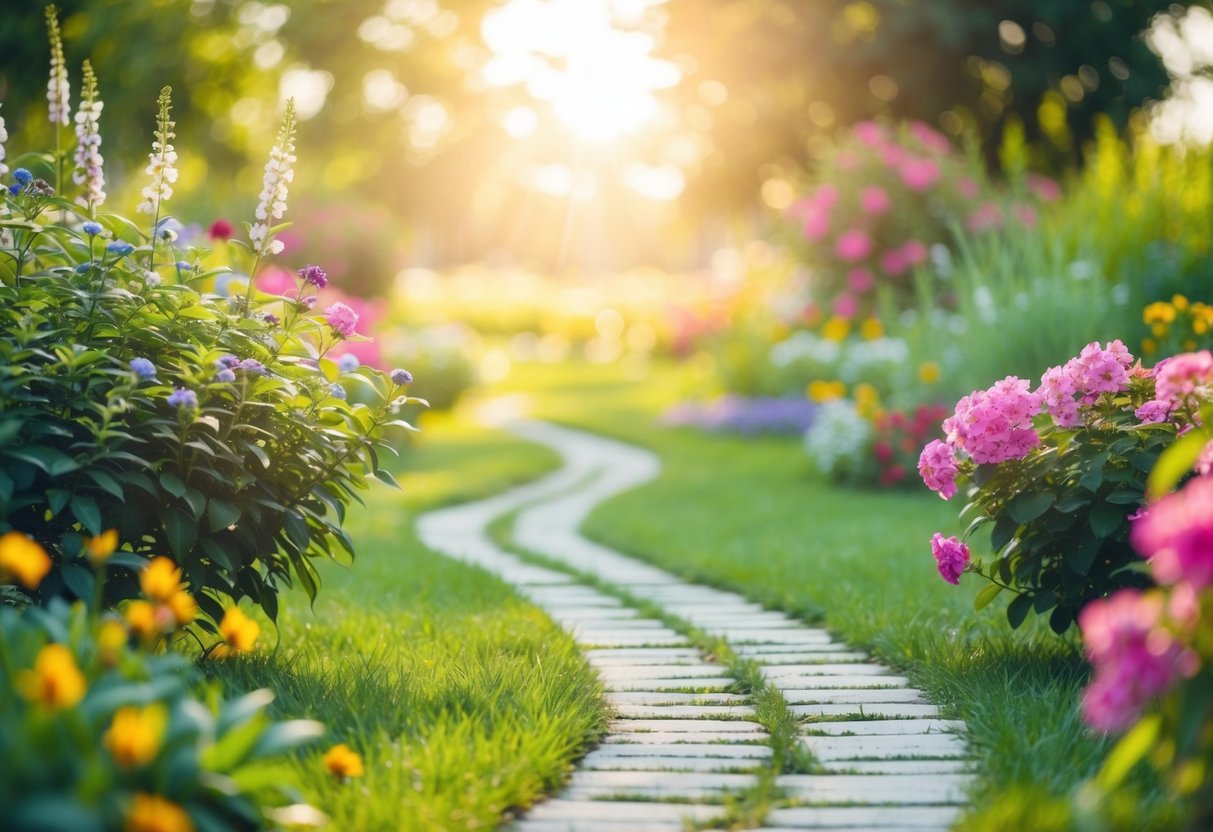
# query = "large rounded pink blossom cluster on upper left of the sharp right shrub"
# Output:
<box><xmin>944</xmin><ymin>376</ymin><xmax>1041</xmax><ymax>465</ymax></box>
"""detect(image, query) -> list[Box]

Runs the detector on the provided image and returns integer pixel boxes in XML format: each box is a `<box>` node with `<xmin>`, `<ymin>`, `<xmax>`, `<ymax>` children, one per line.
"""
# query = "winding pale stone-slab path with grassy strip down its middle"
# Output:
<box><xmin>417</xmin><ymin>421</ymin><xmax>970</xmax><ymax>832</ymax></box>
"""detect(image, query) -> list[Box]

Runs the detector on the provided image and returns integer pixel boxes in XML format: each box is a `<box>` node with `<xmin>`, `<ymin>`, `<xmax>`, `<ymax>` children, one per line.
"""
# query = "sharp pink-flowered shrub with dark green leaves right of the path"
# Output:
<box><xmin>918</xmin><ymin>341</ymin><xmax>1198</xmax><ymax>633</ymax></box>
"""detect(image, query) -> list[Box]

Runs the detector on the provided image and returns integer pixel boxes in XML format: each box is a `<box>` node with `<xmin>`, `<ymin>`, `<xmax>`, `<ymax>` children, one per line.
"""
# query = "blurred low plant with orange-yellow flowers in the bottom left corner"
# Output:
<box><xmin>0</xmin><ymin>602</ymin><xmax>324</xmax><ymax>832</ymax></box>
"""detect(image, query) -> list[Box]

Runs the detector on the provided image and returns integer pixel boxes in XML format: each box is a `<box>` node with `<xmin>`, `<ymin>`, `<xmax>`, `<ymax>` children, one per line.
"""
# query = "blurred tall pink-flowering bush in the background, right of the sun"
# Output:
<box><xmin>788</xmin><ymin>121</ymin><xmax>1059</xmax><ymax>319</ymax></box>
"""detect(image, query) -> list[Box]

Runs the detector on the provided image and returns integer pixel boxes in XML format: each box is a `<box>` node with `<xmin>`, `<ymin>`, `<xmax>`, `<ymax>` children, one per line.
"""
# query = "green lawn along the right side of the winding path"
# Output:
<box><xmin>505</xmin><ymin>365</ymin><xmax>1163</xmax><ymax>830</ymax></box>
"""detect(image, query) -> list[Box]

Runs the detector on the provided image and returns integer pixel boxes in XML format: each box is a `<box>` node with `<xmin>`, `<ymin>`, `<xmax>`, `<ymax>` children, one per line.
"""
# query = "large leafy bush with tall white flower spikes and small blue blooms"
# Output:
<box><xmin>0</xmin><ymin>14</ymin><xmax>414</xmax><ymax>627</ymax></box>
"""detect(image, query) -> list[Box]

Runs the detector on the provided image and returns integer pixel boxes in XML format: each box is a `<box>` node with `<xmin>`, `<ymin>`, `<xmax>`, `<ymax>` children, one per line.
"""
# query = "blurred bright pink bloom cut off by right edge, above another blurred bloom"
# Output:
<box><xmin>1131</xmin><ymin>477</ymin><xmax>1213</xmax><ymax>589</ymax></box>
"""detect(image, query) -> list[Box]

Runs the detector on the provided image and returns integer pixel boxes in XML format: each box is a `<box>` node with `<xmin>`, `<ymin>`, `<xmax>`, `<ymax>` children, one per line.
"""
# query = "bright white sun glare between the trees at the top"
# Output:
<box><xmin>482</xmin><ymin>0</ymin><xmax>682</xmax><ymax>142</ymax></box>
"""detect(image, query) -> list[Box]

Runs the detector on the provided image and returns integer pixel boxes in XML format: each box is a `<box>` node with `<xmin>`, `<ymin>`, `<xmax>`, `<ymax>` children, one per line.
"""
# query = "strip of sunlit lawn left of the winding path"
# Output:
<box><xmin>218</xmin><ymin>414</ymin><xmax>605</xmax><ymax>832</ymax></box>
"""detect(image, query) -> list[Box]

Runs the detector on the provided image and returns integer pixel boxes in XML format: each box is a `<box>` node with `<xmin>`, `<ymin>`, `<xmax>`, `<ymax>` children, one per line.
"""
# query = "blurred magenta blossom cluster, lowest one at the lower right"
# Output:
<box><xmin>1078</xmin><ymin>589</ymin><xmax>1198</xmax><ymax>731</ymax></box>
